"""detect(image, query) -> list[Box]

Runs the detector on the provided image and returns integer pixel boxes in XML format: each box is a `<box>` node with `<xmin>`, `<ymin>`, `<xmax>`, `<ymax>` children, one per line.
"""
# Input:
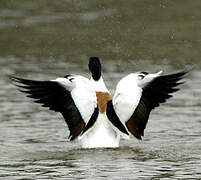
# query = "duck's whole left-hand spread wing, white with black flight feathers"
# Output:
<box><xmin>11</xmin><ymin>75</ymin><xmax>98</xmax><ymax>140</ymax></box>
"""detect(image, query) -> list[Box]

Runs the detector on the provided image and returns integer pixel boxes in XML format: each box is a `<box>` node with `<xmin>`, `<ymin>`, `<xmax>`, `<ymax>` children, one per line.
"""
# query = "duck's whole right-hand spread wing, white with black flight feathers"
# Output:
<box><xmin>107</xmin><ymin>71</ymin><xmax>187</xmax><ymax>139</ymax></box>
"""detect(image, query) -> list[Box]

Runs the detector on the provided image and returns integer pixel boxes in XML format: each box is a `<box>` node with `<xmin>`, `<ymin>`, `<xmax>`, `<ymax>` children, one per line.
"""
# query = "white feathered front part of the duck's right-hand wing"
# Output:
<box><xmin>112</xmin><ymin>71</ymin><xmax>162</xmax><ymax>130</ymax></box>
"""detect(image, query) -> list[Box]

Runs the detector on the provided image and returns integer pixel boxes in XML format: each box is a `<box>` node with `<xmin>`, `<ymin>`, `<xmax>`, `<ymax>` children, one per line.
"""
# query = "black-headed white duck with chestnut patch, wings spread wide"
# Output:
<box><xmin>10</xmin><ymin>57</ymin><xmax>187</xmax><ymax>148</ymax></box>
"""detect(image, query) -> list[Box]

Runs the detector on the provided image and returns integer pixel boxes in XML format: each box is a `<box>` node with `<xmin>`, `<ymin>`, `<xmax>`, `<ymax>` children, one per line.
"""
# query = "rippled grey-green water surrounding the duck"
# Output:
<box><xmin>0</xmin><ymin>0</ymin><xmax>201</xmax><ymax>180</ymax></box>
